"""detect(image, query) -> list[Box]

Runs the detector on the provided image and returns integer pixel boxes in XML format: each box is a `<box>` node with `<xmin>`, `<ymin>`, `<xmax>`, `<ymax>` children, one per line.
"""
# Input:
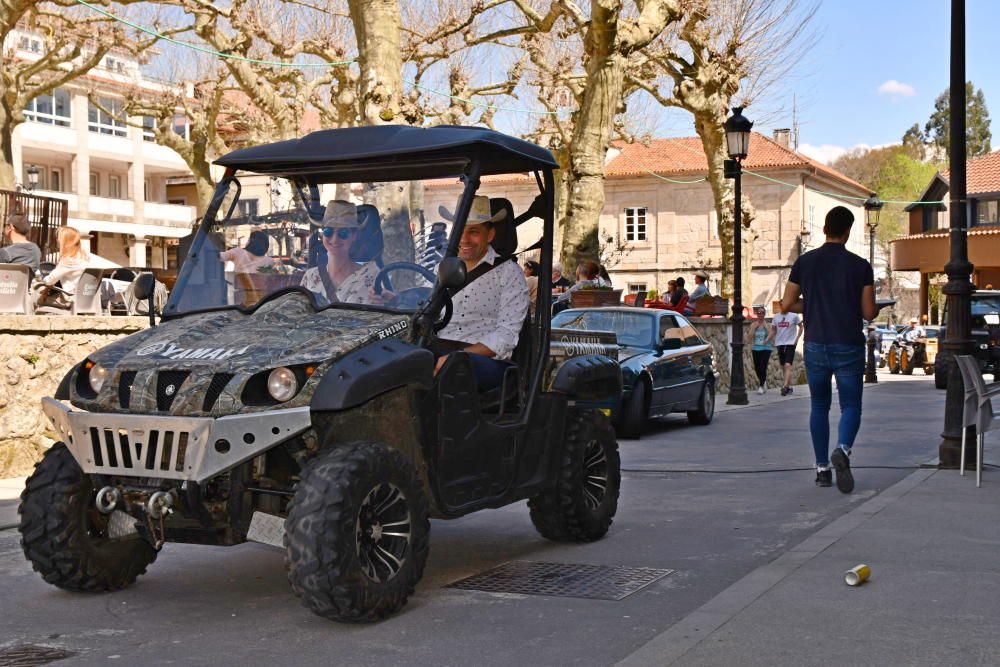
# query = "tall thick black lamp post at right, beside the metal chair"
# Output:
<box><xmin>938</xmin><ymin>0</ymin><xmax>977</xmax><ymax>468</ymax></box>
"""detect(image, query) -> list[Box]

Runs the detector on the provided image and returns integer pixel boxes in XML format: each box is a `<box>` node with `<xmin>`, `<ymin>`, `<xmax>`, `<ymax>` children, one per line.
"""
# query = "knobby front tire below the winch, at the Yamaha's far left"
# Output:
<box><xmin>18</xmin><ymin>442</ymin><xmax>156</xmax><ymax>593</ymax></box>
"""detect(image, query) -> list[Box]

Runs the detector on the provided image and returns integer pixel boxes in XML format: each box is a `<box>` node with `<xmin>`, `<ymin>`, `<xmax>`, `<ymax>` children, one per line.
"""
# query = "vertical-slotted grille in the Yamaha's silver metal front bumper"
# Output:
<box><xmin>89</xmin><ymin>426</ymin><xmax>191</xmax><ymax>476</ymax></box>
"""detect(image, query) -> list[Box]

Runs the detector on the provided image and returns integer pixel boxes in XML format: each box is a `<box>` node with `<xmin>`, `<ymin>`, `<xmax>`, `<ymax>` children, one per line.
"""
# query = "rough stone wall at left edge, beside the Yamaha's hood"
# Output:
<box><xmin>0</xmin><ymin>315</ymin><xmax>149</xmax><ymax>478</ymax></box>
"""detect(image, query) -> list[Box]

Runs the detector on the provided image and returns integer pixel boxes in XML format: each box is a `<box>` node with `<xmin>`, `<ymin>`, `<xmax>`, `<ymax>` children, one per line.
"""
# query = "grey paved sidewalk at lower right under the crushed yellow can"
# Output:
<box><xmin>618</xmin><ymin>460</ymin><xmax>1000</xmax><ymax>667</ymax></box>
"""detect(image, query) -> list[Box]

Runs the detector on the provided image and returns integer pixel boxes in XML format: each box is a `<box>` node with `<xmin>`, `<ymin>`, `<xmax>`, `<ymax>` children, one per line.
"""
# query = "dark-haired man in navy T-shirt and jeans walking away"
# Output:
<box><xmin>781</xmin><ymin>206</ymin><xmax>879</xmax><ymax>493</ymax></box>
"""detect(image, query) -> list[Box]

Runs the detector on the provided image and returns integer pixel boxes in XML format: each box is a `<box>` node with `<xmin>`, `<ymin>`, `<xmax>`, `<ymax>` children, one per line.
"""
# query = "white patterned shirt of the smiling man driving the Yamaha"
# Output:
<box><xmin>439</xmin><ymin>246</ymin><xmax>529</xmax><ymax>359</ymax></box>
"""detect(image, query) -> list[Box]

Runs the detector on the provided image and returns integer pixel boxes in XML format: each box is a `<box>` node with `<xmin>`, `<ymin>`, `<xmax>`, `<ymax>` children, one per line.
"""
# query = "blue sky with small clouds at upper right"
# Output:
<box><xmin>752</xmin><ymin>0</ymin><xmax>1000</xmax><ymax>165</ymax></box>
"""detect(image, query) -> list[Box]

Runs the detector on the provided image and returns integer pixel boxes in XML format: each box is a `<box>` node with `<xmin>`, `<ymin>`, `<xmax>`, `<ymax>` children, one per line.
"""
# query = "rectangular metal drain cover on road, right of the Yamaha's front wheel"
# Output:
<box><xmin>449</xmin><ymin>561</ymin><xmax>673</xmax><ymax>600</ymax></box>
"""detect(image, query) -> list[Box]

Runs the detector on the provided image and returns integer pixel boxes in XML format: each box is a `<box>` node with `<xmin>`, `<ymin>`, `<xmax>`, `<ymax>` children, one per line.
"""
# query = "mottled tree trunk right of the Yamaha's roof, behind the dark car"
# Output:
<box><xmin>560</xmin><ymin>2</ymin><xmax>626</xmax><ymax>273</ymax></box>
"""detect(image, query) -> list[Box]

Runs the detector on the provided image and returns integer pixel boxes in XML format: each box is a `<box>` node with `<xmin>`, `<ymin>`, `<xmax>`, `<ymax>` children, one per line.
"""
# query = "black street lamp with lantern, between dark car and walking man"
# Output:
<box><xmin>724</xmin><ymin>107</ymin><xmax>753</xmax><ymax>405</ymax></box>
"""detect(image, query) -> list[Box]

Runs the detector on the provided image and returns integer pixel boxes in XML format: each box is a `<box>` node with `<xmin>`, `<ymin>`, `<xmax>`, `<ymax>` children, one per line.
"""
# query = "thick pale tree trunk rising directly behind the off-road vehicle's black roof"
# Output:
<box><xmin>348</xmin><ymin>0</ymin><xmax>413</xmax><ymax>266</ymax></box>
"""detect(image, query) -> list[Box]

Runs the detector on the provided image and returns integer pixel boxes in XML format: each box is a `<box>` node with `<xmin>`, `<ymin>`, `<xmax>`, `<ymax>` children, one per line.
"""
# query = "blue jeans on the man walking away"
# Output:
<box><xmin>805</xmin><ymin>343</ymin><xmax>865</xmax><ymax>466</ymax></box>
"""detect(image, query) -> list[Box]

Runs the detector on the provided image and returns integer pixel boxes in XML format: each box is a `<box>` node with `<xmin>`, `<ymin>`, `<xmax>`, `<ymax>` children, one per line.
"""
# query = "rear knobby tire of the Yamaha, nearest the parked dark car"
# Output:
<box><xmin>528</xmin><ymin>410</ymin><xmax>621</xmax><ymax>542</ymax></box>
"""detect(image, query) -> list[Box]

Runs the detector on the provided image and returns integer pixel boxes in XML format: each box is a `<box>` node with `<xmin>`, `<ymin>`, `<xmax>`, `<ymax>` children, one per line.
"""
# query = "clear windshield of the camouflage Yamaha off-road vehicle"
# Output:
<box><xmin>166</xmin><ymin>174</ymin><xmax>541</xmax><ymax>315</ymax></box>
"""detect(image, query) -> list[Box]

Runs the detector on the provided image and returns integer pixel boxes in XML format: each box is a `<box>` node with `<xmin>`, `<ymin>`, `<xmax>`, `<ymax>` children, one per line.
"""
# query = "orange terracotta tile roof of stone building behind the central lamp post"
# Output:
<box><xmin>606</xmin><ymin>132</ymin><xmax>871</xmax><ymax>193</ymax></box>
